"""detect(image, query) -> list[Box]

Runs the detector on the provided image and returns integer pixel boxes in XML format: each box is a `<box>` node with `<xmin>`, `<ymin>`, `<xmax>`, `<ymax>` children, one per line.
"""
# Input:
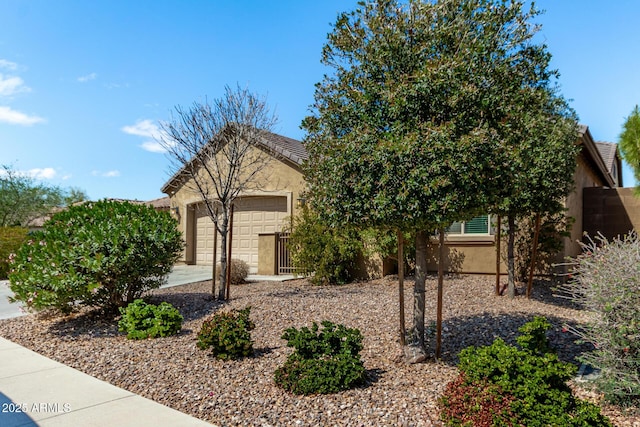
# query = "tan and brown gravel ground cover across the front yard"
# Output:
<box><xmin>0</xmin><ymin>276</ymin><xmax>640</xmax><ymax>427</ymax></box>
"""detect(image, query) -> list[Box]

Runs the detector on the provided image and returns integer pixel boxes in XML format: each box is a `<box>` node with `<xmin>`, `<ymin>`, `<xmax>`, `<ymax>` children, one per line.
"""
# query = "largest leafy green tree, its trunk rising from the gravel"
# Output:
<box><xmin>303</xmin><ymin>0</ymin><xmax>576</xmax><ymax>362</ymax></box>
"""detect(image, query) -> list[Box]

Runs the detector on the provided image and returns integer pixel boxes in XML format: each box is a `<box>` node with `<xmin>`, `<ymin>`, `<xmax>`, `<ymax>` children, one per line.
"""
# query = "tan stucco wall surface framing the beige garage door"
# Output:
<box><xmin>168</xmin><ymin>149</ymin><xmax>306</xmax><ymax>263</ymax></box>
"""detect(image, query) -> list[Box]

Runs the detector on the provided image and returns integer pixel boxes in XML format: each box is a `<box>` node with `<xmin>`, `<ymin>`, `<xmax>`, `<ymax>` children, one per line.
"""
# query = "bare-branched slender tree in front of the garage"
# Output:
<box><xmin>158</xmin><ymin>86</ymin><xmax>277</xmax><ymax>300</ymax></box>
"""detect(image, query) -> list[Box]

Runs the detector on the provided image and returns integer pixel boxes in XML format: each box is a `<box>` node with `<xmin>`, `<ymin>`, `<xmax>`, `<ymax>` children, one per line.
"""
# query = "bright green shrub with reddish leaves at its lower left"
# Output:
<box><xmin>440</xmin><ymin>318</ymin><xmax>611</xmax><ymax>426</ymax></box>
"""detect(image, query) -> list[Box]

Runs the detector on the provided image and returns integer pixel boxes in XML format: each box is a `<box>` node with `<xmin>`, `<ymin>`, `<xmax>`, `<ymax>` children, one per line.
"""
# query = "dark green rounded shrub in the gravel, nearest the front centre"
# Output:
<box><xmin>274</xmin><ymin>321</ymin><xmax>365</xmax><ymax>395</ymax></box>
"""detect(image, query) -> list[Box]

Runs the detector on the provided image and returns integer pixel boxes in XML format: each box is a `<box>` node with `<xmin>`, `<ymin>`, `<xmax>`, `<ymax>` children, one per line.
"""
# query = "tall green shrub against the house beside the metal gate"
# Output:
<box><xmin>289</xmin><ymin>206</ymin><xmax>362</xmax><ymax>284</ymax></box>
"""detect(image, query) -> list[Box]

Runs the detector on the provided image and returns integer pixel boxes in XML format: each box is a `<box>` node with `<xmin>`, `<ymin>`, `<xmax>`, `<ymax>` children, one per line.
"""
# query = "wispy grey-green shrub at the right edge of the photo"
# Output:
<box><xmin>560</xmin><ymin>232</ymin><xmax>640</xmax><ymax>405</ymax></box>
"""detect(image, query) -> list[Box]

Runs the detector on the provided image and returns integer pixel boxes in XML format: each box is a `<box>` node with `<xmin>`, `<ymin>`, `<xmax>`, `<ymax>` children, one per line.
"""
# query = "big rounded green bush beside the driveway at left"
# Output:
<box><xmin>9</xmin><ymin>201</ymin><xmax>183</xmax><ymax>313</ymax></box>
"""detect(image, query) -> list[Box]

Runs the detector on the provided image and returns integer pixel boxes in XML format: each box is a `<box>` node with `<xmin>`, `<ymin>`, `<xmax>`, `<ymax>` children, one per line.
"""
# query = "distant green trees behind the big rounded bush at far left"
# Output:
<box><xmin>0</xmin><ymin>165</ymin><xmax>87</xmax><ymax>227</ymax></box>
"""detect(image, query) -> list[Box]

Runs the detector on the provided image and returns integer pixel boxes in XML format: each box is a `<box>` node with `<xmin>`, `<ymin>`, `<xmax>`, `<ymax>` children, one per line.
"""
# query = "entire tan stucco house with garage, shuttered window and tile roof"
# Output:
<box><xmin>162</xmin><ymin>126</ymin><xmax>622</xmax><ymax>274</ymax></box>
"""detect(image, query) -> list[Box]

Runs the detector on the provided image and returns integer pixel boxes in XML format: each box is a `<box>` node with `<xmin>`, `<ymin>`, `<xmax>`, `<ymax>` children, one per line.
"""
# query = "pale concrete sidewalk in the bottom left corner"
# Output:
<box><xmin>0</xmin><ymin>338</ymin><xmax>211</xmax><ymax>427</ymax></box>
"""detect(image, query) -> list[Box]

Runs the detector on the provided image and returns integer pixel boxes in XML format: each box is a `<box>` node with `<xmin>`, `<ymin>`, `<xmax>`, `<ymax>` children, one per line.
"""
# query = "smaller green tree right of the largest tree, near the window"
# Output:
<box><xmin>492</xmin><ymin>88</ymin><xmax>580</xmax><ymax>297</ymax></box>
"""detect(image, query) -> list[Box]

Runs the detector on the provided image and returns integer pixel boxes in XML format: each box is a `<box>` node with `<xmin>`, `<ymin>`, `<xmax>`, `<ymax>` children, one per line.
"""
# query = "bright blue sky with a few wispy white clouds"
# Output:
<box><xmin>0</xmin><ymin>0</ymin><xmax>640</xmax><ymax>200</ymax></box>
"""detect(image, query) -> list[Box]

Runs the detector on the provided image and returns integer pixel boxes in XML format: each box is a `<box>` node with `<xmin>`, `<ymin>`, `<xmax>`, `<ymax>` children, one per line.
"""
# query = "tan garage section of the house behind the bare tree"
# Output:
<box><xmin>162</xmin><ymin>133</ymin><xmax>307</xmax><ymax>274</ymax></box>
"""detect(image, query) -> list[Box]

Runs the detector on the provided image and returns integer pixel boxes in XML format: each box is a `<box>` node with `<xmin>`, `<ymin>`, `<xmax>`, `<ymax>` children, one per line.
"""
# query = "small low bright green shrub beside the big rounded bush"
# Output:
<box><xmin>118</xmin><ymin>299</ymin><xmax>183</xmax><ymax>340</ymax></box>
